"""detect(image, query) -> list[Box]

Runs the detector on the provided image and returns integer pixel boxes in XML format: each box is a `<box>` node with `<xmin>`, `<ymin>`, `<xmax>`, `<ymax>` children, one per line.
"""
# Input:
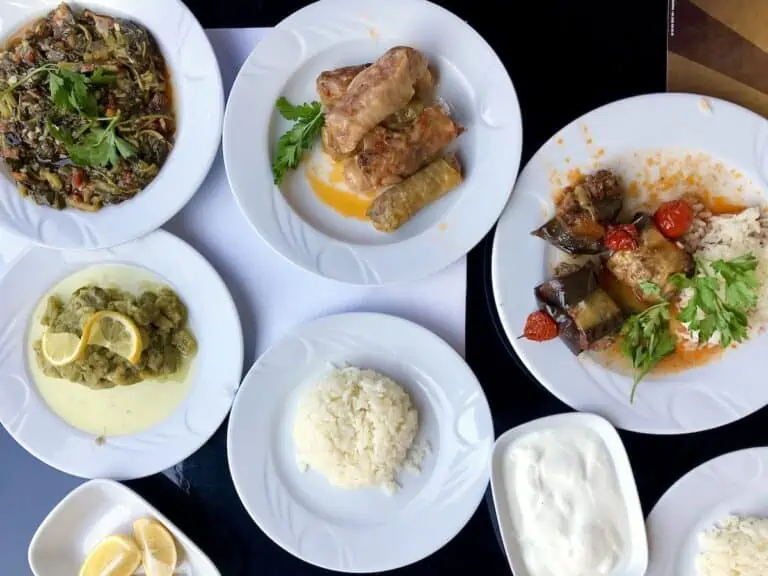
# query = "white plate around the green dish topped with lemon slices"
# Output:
<box><xmin>0</xmin><ymin>231</ymin><xmax>243</xmax><ymax>480</ymax></box>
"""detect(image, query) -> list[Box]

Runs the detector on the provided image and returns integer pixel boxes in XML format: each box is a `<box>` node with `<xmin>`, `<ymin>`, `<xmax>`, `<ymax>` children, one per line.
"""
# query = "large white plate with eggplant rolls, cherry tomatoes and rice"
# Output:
<box><xmin>491</xmin><ymin>94</ymin><xmax>768</xmax><ymax>434</ymax></box>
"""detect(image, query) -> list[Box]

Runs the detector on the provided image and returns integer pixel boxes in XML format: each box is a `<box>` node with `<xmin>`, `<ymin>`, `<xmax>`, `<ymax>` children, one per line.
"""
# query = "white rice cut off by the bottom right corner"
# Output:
<box><xmin>696</xmin><ymin>516</ymin><xmax>768</xmax><ymax>576</ymax></box>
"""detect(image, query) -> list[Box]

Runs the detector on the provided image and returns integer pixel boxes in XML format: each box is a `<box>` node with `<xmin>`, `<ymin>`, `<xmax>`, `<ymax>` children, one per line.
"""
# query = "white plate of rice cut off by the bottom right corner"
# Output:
<box><xmin>646</xmin><ymin>448</ymin><xmax>768</xmax><ymax>576</ymax></box>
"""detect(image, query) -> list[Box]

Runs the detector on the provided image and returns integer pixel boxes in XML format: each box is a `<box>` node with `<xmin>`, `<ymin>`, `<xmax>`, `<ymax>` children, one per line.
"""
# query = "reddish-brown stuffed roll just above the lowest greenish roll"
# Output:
<box><xmin>344</xmin><ymin>106</ymin><xmax>464</xmax><ymax>192</ymax></box>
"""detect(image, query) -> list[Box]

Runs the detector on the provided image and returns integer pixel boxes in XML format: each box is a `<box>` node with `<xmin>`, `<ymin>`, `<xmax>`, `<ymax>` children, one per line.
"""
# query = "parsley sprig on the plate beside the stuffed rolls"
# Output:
<box><xmin>272</xmin><ymin>96</ymin><xmax>325</xmax><ymax>184</ymax></box>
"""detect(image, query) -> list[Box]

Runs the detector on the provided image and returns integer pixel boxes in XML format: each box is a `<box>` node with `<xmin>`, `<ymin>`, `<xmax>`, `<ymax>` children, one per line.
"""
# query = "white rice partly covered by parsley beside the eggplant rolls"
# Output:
<box><xmin>679</xmin><ymin>207</ymin><xmax>768</xmax><ymax>345</ymax></box>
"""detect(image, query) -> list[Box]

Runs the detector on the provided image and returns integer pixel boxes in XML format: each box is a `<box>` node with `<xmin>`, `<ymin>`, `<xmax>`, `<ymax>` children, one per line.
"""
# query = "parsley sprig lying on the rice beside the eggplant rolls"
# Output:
<box><xmin>670</xmin><ymin>254</ymin><xmax>760</xmax><ymax>348</ymax></box>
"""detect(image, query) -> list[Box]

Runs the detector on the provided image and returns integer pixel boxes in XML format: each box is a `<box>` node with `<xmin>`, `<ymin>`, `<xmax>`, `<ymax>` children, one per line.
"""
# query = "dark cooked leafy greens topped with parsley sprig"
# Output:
<box><xmin>0</xmin><ymin>4</ymin><xmax>176</xmax><ymax>212</ymax></box>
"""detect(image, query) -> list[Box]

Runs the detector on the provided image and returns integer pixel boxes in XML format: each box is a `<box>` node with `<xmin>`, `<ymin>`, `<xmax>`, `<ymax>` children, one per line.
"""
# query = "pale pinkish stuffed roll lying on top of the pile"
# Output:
<box><xmin>325</xmin><ymin>46</ymin><xmax>431</xmax><ymax>154</ymax></box>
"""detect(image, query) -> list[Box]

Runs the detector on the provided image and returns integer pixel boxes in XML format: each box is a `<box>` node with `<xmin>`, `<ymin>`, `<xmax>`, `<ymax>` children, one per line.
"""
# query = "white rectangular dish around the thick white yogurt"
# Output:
<box><xmin>491</xmin><ymin>413</ymin><xmax>648</xmax><ymax>576</ymax></box>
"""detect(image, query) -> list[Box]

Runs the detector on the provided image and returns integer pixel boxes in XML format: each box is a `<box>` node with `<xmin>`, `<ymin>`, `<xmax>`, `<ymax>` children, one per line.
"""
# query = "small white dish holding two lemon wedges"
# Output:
<box><xmin>28</xmin><ymin>480</ymin><xmax>219</xmax><ymax>576</ymax></box>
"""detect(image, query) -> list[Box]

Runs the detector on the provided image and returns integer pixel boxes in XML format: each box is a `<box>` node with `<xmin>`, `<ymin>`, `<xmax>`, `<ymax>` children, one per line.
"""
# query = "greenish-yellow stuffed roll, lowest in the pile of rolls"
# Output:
<box><xmin>368</xmin><ymin>154</ymin><xmax>462</xmax><ymax>232</ymax></box>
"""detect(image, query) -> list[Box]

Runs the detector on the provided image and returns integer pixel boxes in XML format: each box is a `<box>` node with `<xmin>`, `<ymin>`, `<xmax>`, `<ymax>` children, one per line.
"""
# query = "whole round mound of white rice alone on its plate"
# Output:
<box><xmin>293</xmin><ymin>367</ymin><xmax>426</xmax><ymax>494</ymax></box>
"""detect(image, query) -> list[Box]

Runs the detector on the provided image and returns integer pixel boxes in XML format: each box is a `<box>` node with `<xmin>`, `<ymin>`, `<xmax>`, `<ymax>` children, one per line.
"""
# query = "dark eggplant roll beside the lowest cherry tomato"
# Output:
<box><xmin>534</xmin><ymin>266</ymin><xmax>624</xmax><ymax>354</ymax></box>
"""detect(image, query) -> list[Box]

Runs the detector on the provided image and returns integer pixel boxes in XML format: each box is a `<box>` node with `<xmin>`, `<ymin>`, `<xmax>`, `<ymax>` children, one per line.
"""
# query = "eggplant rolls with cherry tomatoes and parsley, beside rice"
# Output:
<box><xmin>522</xmin><ymin>170</ymin><xmax>752</xmax><ymax>399</ymax></box>
